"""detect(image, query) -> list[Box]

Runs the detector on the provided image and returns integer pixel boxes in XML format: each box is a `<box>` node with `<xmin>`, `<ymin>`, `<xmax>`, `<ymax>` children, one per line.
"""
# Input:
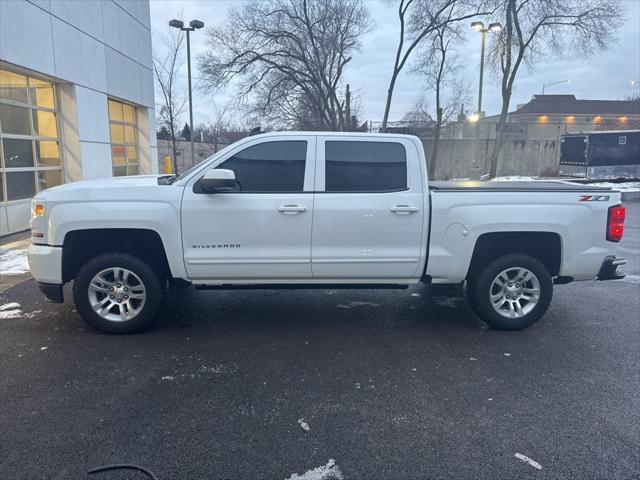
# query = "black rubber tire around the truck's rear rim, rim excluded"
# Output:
<box><xmin>467</xmin><ymin>253</ymin><xmax>553</xmax><ymax>330</ymax></box>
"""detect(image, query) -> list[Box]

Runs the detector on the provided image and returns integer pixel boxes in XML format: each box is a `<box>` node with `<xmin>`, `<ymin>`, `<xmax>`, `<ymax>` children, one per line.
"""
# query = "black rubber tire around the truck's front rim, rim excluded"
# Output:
<box><xmin>73</xmin><ymin>253</ymin><xmax>162</xmax><ymax>334</ymax></box>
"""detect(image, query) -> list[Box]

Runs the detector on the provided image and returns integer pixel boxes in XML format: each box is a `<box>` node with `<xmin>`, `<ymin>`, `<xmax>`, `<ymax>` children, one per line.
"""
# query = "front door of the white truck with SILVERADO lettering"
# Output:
<box><xmin>182</xmin><ymin>135</ymin><xmax>315</xmax><ymax>283</ymax></box>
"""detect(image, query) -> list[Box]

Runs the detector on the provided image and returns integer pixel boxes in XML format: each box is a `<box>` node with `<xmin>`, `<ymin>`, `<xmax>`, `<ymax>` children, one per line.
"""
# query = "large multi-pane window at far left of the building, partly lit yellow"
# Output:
<box><xmin>0</xmin><ymin>69</ymin><xmax>63</xmax><ymax>202</ymax></box>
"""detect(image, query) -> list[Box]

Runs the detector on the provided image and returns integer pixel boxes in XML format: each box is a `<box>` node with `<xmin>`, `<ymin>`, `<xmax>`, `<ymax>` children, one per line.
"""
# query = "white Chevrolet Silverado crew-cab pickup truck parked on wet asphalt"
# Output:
<box><xmin>29</xmin><ymin>132</ymin><xmax>625</xmax><ymax>333</ymax></box>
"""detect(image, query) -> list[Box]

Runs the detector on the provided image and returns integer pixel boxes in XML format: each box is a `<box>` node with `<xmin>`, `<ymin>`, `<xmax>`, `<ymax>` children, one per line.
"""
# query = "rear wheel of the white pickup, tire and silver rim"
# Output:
<box><xmin>467</xmin><ymin>254</ymin><xmax>553</xmax><ymax>330</ymax></box>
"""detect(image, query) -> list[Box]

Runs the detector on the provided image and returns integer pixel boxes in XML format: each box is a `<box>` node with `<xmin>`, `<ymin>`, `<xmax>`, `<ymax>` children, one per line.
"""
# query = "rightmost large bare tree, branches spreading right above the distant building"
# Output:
<box><xmin>489</xmin><ymin>0</ymin><xmax>623</xmax><ymax>178</ymax></box>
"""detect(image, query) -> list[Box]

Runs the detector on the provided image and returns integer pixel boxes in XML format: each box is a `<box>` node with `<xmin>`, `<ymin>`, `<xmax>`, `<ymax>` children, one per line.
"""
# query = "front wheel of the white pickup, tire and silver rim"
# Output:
<box><xmin>73</xmin><ymin>253</ymin><xmax>162</xmax><ymax>333</ymax></box>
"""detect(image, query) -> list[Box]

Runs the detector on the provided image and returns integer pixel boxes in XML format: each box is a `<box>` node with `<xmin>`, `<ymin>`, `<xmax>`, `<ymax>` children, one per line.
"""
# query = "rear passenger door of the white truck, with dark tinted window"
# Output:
<box><xmin>311</xmin><ymin>136</ymin><xmax>426</xmax><ymax>280</ymax></box>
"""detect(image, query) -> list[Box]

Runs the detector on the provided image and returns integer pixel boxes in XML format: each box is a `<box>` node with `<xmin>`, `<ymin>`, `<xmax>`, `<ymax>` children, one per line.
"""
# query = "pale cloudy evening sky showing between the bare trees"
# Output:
<box><xmin>150</xmin><ymin>0</ymin><xmax>640</xmax><ymax>125</ymax></box>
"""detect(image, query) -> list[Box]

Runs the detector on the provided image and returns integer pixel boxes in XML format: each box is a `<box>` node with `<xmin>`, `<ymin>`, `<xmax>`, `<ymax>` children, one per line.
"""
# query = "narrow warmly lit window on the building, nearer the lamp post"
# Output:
<box><xmin>109</xmin><ymin>99</ymin><xmax>139</xmax><ymax>177</ymax></box>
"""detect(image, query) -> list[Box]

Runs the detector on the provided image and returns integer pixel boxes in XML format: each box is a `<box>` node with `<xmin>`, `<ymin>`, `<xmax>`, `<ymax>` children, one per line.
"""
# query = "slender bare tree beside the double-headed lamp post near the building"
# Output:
<box><xmin>153</xmin><ymin>30</ymin><xmax>187</xmax><ymax>173</ymax></box>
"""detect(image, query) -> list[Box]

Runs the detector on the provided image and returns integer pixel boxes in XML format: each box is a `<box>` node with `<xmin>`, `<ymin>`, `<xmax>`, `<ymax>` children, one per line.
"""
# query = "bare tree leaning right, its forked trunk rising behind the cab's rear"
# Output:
<box><xmin>382</xmin><ymin>0</ymin><xmax>495</xmax><ymax>128</ymax></box>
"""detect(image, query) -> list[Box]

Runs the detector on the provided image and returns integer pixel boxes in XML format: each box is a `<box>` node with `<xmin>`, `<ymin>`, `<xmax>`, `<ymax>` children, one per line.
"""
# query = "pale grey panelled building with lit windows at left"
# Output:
<box><xmin>0</xmin><ymin>0</ymin><xmax>158</xmax><ymax>236</ymax></box>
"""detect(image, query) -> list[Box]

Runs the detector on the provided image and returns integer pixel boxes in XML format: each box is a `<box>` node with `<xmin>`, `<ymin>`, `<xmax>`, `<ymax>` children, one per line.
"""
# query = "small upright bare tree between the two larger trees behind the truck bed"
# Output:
<box><xmin>414</xmin><ymin>23</ymin><xmax>470</xmax><ymax>177</ymax></box>
